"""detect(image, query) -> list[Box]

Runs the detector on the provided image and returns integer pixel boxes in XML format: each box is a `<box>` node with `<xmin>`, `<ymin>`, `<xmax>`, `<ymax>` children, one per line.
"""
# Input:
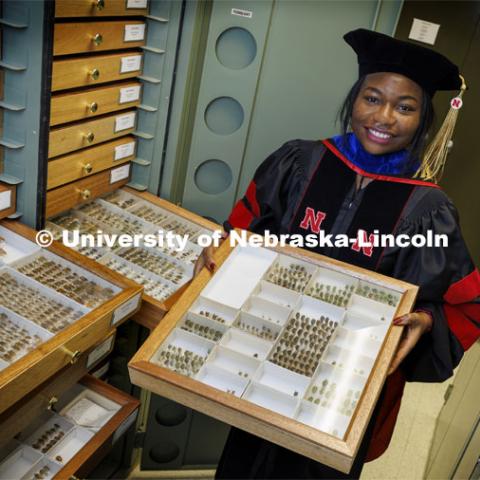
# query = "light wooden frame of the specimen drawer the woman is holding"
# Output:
<box><xmin>129</xmin><ymin>238</ymin><xmax>418</xmax><ymax>473</ymax></box>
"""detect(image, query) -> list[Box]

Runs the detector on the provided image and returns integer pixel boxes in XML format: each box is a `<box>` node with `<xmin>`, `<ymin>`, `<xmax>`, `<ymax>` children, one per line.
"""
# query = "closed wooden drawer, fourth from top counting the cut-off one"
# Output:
<box><xmin>50</xmin><ymin>82</ymin><xmax>142</xmax><ymax>126</ymax></box>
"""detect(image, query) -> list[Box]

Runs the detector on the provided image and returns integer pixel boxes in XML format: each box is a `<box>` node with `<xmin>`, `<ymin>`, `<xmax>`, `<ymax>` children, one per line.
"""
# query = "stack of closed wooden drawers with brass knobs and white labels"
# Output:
<box><xmin>46</xmin><ymin>0</ymin><xmax>148</xmax><ymax>217</ymax></box>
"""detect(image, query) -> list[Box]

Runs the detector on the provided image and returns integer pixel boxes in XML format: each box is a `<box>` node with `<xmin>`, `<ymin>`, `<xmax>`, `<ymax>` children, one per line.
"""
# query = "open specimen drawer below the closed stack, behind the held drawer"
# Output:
<box><xmin>46</xmin><ymin>188</ymin><xmax>221</xmax><ymax>329</ymax></box>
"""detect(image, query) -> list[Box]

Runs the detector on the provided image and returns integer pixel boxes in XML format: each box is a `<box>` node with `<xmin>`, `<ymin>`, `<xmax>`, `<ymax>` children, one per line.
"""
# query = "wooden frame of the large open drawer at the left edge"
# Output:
<box><xmin>0</xmin><ymin>221</ymin><xmax>143</xmax><ymax>414</ymax></box>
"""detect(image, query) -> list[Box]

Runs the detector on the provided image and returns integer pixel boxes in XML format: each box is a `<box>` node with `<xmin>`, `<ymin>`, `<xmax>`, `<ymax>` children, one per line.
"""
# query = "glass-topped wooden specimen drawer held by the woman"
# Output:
<box><xmin>129</xmin><ymin>236</ymin><xmax>417</xmax><ymax>472</ymax></box>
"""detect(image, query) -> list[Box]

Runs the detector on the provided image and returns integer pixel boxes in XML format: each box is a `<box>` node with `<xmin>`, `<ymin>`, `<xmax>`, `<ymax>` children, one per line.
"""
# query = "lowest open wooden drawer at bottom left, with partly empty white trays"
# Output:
<box><xmin>0</xmin><ymin>375</ymin><xmax>139</xmax><ymax>479</ymax></box>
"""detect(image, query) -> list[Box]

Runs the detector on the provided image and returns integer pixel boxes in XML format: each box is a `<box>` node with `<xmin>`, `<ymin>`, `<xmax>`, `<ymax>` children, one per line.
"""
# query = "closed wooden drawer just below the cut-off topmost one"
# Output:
<box><xmin>53</xmin><ymin>20</ymin><xmax>146</xmax><ymax>55</ymax></box>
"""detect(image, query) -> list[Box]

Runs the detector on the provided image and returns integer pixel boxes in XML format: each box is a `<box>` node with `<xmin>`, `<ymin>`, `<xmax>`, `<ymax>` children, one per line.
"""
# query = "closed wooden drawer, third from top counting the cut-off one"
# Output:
<box><xmin>52</xmin><ymin>51</ymin><xmax>143</xmax><ymax>92</ymax></box>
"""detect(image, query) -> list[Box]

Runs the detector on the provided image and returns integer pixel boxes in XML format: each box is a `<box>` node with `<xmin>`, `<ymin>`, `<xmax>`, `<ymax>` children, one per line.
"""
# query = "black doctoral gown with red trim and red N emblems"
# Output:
<box><xmin>217</xmin><ymin>140</ymin><xmax>480</xmax><ymax>478</ymax></box>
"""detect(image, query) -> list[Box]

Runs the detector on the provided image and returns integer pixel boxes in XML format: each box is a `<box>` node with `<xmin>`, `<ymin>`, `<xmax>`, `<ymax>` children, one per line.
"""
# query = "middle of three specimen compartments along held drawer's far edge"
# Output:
<box><xmin>305</xmin><ymin>267</ymin><xmax>358</xmax><ymax>308</ymax></box>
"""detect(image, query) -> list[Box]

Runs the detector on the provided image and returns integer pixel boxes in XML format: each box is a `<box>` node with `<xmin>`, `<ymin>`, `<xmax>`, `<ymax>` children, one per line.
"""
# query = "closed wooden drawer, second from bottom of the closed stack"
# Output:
<box><xmin>47</xmin><ymin>135</ymin><xmax>136</xmax><ymax>190</ymax></box>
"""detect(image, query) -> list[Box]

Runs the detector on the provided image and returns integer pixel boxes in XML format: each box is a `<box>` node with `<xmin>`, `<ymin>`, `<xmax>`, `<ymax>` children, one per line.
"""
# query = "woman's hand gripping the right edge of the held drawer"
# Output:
<box><xmin>388</xmin><ymin>312</ymin><xmax>433</xmax><ymax>375</ymax></box>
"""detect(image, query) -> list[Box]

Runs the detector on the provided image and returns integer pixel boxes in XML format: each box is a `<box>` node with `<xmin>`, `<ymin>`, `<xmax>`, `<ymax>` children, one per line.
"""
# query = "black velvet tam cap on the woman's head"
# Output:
<box><xmin>343</xmin><ymin>28</ymin><xmax>462</xmax><ymax>96</ymax></box>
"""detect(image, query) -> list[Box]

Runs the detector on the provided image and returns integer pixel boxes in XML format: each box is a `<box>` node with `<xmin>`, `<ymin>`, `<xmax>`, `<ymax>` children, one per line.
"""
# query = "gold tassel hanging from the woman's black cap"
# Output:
<box><xmin>414</xmin><ymin>75</ymin><xmax>467</xmax><ymax>183</ymax></box>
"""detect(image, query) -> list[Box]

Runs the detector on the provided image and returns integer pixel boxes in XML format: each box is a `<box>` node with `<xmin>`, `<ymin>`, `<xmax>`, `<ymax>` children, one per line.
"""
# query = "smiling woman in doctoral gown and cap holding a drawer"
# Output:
<box><xmin>195</xmin><ymin>29</ymin><xmax>480</xmax><ymax>478</ymax></box>
